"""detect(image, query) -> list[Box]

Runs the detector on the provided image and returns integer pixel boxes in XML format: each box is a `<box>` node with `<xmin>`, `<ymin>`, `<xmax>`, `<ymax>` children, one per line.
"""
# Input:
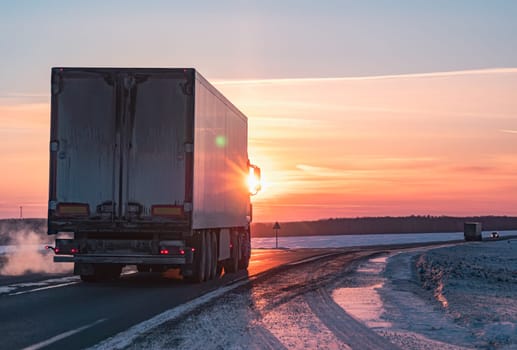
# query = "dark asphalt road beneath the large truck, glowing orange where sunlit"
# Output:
<box><xmin>0</xmin><ymin>249</ymin><xmax>336</xmax><ymax>349</ymax></box>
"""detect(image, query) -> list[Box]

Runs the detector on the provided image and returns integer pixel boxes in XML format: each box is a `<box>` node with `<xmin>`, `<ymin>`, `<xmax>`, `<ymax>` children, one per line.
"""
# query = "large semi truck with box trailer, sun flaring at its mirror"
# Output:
<box><xmin>48</xmin><ymin>67</ymin><xmax>260</xmax><ymax>282</ymax></box>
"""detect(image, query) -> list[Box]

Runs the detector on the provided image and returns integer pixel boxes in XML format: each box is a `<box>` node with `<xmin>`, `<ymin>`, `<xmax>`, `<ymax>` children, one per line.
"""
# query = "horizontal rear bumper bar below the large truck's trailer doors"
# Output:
<box><xmin>54</xmin><ymin>254</ymin><xmax>188</xmax><ymax>265</ymax></box>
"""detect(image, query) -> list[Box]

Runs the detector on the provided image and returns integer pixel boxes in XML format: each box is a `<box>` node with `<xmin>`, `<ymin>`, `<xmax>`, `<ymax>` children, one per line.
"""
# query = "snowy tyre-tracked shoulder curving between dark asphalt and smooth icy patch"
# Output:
<box><xmin>95</xmin><ymin>251</ymin><xmax>396</xmax><ymax>349</ymax></box>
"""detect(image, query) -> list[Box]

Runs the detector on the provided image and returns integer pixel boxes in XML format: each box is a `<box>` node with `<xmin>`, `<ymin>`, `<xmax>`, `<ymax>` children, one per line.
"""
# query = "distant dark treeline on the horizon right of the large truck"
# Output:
<box><xmin>252</xmin><ymin>216</ymin><xmax>517</xmax><ymax>237</ymax></box>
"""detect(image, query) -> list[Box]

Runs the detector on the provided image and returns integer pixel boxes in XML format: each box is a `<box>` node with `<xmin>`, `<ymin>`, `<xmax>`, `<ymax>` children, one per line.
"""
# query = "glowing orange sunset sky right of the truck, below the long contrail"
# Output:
<box><xmin>216</xmin><ymin>69</ymin><xmax>517</xmax><ymax>221</ymax></box>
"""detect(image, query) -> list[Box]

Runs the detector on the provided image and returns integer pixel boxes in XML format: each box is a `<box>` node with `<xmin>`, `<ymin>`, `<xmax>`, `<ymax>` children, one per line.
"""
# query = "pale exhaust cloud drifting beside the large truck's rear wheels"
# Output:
<box><xmin>0</xmin><ymin>221</ymin><xmax>73</xmax><ymax>276</ymax></box>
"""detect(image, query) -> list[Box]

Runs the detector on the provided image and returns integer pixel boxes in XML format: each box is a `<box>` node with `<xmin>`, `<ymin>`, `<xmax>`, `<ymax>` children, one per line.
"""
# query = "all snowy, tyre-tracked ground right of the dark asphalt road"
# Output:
<box><xmin>93</xmin><ymin>239</ymin><xmax>517</xmax><ymax>350</ymax></box>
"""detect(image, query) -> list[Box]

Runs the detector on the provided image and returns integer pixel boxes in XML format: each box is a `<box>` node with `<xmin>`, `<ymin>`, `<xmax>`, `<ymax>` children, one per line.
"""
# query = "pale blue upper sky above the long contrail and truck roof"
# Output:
<box><xmin>0</xmin><ymin>0</ymin><xmax>517</xmax><ymax>95</ymax></box>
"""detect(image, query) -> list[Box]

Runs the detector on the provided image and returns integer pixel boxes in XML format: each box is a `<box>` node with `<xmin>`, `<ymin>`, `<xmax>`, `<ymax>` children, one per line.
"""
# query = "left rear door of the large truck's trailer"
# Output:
<box><xmin>50</xmin><ymin>69</ymin><xmax>120</xmax><ymax>217</ymax></box>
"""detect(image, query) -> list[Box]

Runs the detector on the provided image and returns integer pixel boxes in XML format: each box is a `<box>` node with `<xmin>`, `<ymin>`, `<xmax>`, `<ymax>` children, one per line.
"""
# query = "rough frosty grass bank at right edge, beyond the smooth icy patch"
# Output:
<box><xmin>416</xmin><ymin>240</ymin><xmax>517</xmax><ymax>349</ymax></box>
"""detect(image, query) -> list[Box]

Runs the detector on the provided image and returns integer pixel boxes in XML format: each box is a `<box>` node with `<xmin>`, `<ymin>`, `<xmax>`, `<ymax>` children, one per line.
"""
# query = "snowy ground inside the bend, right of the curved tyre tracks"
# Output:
<box><xmin>333</xmin><ymin>240</ymin><xmax>517</xmax><ymax>349</ymax></box>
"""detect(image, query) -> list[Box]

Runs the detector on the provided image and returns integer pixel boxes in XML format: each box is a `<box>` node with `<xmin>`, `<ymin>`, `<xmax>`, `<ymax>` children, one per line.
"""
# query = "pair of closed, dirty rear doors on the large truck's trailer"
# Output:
<box><xmin>49</xmin><ymin>68</ymin><xmax>192</xmax><ymax>221</ymax></box>
